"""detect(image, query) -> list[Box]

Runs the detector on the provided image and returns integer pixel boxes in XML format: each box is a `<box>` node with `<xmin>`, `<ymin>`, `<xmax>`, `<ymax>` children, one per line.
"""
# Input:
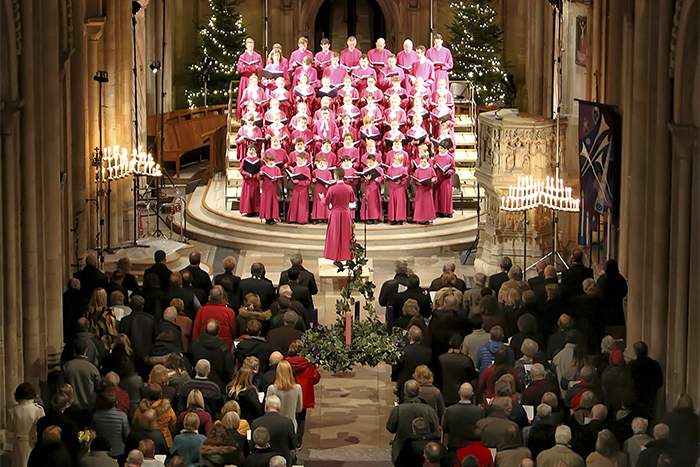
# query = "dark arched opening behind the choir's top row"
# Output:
<box><xmin>309</xmin><ymin>0</ymin><xmax>386</xmax><ymax>52</ymax></box>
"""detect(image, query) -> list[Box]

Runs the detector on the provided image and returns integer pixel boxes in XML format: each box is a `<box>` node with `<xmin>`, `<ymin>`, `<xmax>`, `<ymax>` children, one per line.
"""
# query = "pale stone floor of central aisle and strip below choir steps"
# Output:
<box><xmin>190</xmin><ymin>239</ymin><xmax>473</xmax><ymax>458</ymax></box>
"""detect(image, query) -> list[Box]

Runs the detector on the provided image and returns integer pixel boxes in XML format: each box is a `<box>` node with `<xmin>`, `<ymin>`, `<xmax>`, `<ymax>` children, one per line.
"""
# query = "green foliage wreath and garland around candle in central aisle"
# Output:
<box><xmin>302</xmin><ymin>241</ymin><xmax>403</xmax><ymax>373</ymax></box>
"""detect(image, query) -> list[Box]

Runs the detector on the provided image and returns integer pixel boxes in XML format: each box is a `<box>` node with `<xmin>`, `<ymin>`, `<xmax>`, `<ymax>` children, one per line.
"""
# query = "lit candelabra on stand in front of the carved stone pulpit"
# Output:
<box><xmin>501</xmin><ymin>175</ymin><xmax>581</xmax><ymax>271</ymax></box>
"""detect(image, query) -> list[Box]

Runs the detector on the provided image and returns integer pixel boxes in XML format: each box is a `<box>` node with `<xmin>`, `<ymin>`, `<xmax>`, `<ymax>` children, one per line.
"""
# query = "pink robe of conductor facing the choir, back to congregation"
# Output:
<box><xmin>323</xmin><ymin>182</ymin><xmax>355</xmax><ymax>261</ymax></box>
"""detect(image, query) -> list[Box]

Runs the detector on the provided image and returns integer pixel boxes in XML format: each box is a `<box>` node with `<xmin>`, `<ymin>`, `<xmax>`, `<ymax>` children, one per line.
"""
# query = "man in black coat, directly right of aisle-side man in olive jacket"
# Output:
<box><xmin>442</xmin><ymin>383</ymin><xmax>484</xmax><ymax>465</ymax></box>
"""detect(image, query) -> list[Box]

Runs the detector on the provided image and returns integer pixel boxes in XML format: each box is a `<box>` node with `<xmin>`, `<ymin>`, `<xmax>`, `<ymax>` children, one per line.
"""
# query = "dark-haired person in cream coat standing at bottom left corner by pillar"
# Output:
<box><xmin>7</xmin><ymin>383</ymin><xmax>45</xmax><ymax>467</ymax></box>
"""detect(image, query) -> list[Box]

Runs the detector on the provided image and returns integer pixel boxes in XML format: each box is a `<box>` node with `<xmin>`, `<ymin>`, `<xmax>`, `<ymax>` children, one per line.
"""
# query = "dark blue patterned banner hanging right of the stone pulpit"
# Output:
<box><xmin>577</xmin><ymin>99</ymin><xmax>620</xmax><ymax>249</ymax></box>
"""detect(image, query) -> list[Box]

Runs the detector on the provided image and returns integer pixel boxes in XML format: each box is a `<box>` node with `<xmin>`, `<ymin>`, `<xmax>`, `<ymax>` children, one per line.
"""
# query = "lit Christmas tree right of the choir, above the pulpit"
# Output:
<box><xmin>449</xmin><ymin>0</ymin><xmax>506</xmax><ymax>104</ymax></box>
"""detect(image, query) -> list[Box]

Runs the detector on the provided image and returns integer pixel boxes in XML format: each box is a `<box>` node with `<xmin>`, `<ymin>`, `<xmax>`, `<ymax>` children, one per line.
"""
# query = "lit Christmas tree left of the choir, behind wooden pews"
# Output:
<box><xmin>185</xmin><ymin>0</ymin><xmax>246</xmax><ymax>108</ymax></box>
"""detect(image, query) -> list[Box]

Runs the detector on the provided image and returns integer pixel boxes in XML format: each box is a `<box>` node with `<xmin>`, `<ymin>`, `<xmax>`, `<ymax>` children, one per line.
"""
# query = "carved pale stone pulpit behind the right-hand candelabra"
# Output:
<box><xmin>474</xmin><ymin>109</ymin><xmax>578</xmax><ymax>274</ymax></box>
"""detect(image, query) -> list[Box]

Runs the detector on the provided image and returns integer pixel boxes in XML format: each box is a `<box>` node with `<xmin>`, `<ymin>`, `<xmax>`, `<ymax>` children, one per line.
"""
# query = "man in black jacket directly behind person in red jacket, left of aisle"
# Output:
<box><xmin>190</xmin><ymin>319</ymin><xmax>236</xmax><ymax>391</ymax></box>
